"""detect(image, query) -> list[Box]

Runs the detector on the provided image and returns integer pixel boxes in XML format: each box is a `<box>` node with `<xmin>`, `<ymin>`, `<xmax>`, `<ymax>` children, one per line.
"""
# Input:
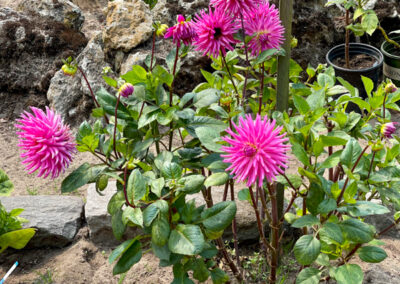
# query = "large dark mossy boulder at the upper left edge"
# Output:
<box><xmin>0</xmin><ymin>8</ymin><xmax>87</xmax><ymax>115</ymax></box>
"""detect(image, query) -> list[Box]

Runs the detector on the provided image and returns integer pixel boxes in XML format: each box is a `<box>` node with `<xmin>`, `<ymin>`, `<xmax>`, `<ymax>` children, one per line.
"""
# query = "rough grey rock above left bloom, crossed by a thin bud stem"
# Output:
<box><xmin>47</xmin><ymin>30</ymin><xmax>110</xmax><ymax>126</ymax></box>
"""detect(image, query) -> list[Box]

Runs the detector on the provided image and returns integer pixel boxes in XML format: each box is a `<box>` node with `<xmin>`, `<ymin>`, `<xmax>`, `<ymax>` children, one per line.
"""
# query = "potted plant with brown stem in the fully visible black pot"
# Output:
<box><xmin>326</xmin><ymin>0</ymin><xmax>383</xmax><ymax>98</ymax></box>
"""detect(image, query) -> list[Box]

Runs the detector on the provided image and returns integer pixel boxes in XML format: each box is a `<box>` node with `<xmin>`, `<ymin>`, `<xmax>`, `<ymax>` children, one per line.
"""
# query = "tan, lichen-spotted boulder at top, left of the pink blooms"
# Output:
<box><xmin>103</xmin><ymin>0</ymin><xmax>153</xmax><ymax>51</ymax></box>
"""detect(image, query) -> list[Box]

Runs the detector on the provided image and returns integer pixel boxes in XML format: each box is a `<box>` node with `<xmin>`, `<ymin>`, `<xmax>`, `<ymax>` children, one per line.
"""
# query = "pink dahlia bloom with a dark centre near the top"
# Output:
<box><xmin>194</xmin><ymin>7</ymin><xmax>238</xmax><ymax>57</ymax></box>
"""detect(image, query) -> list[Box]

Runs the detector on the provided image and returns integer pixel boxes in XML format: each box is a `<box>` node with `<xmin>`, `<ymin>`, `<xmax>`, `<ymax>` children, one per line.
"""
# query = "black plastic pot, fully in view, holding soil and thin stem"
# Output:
<box><xmin>326</xmin><ymin>43</ymin><xmax>383</xmax><ymax>99</ymax></box>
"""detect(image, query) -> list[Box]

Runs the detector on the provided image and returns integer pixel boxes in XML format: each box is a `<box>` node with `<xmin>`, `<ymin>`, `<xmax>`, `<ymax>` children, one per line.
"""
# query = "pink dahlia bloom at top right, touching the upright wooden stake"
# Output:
<box><xmin>244</xmin><ymin>1</ymin><xmax>285</xmax><ymax>56</ymax></box>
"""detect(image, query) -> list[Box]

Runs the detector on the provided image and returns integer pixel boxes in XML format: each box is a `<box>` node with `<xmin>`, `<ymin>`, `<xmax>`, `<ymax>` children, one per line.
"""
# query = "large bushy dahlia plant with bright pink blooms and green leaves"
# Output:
<box><xmin>18</xmin><ymin>0</ymin><xmax>400</xmax><ymax>283</ymax></box>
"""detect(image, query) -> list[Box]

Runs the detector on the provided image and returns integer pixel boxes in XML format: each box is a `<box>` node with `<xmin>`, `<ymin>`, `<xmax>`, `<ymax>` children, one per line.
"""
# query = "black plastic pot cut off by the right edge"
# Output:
<box><xmin>381</xmin><ymin>35</ymin><xmax>400</xmax><ymax>87</ymax></box>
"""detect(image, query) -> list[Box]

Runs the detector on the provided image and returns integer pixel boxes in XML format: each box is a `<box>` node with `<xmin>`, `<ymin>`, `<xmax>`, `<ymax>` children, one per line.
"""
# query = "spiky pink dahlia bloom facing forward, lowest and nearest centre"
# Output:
<box><xmin>221</xmin><ymin>114</ymin><xmax>290</xmax><ymax>186</ymax></box>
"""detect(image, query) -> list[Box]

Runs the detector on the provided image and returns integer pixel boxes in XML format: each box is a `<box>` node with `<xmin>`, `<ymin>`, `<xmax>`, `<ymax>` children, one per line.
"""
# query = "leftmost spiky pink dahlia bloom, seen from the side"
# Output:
<box><xmin>15</xmin><ymin>107</ymin><xmax>76</xmax><ymax>179</ymax></box>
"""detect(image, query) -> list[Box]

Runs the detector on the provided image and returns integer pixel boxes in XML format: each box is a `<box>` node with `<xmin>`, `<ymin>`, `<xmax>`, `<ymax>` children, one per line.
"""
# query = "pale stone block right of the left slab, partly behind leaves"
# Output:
<box><xmin>85</xmin><ymin>182</ymin><xmax>140</xmax><ymax>246</ymax></box>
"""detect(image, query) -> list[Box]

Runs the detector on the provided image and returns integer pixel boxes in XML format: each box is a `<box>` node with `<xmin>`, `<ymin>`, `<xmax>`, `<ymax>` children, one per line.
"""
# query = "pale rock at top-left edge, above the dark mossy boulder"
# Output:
<box><xmin>18</xmin><ymin>0</ymin><xmax>85</xmax><ymax>31</ymax></box>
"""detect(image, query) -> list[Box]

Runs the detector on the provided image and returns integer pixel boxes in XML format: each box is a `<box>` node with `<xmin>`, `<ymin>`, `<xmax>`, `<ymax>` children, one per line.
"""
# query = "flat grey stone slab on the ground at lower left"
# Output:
<box><xmin>0</xmin><ymin>195</ymin><xmax>83</xmax><ymax>248</ymax></box>
